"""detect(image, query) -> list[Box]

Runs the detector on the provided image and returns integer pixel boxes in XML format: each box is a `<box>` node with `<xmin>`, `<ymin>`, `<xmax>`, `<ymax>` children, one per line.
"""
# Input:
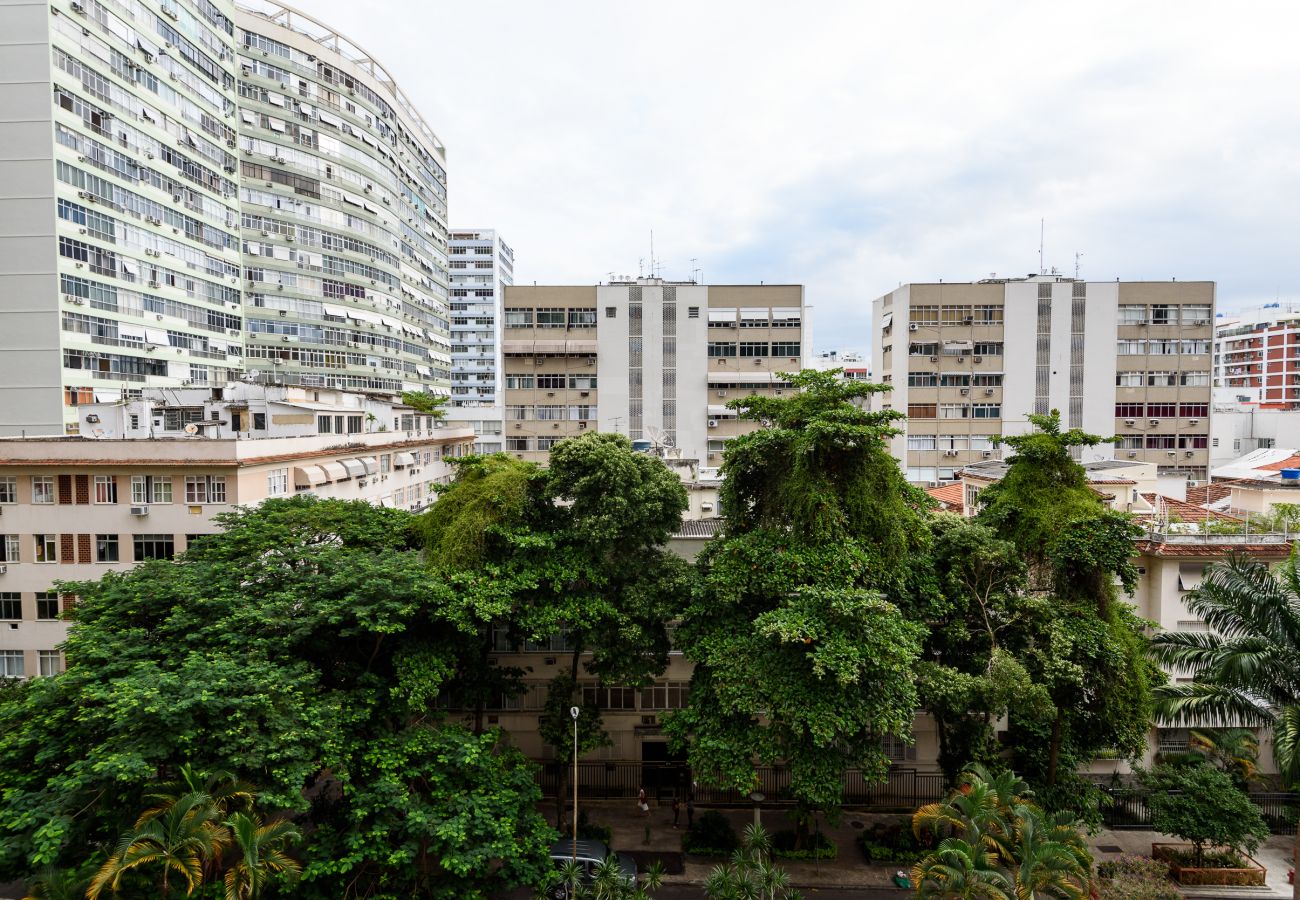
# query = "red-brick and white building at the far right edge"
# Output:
<box><xmin>1214</xmin><ymin>303</ymin><xmax>1300</xmax><ymax>410</ymax></box>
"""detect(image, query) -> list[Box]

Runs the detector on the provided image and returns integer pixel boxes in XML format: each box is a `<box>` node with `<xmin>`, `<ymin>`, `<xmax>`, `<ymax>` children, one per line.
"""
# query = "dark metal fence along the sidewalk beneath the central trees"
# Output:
<box><xmin>527</xmin><ymin>760</ymin><xmax>945</xmax><ymax>810</ymax></box>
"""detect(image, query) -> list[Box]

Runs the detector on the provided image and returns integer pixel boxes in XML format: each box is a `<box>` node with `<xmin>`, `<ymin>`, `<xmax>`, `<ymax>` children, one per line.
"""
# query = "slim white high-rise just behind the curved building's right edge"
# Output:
<box><xmin>446</xmin><ymin>228</ymin><xmax>515</xmax><ymax>453</ymax></box>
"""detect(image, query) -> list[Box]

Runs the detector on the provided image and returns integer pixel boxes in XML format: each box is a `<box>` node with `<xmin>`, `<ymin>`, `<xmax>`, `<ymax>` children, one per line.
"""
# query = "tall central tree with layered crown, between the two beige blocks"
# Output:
<box><xmin>667</xmin><ymin>371</ymin><xmax>926</xmax><ymax>832</ymax></box>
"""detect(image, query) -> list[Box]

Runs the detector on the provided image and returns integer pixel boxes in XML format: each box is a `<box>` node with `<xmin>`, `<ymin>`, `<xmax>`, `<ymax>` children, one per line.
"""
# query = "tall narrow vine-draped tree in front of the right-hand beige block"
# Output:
<box><xmin>976</xmin><ymin>410</ymin><xmax>1161</xmax><ymax>802</ymax></box>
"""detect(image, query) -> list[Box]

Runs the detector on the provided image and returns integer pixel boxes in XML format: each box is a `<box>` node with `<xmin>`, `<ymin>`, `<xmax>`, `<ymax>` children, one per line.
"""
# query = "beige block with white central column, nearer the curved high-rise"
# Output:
<box><xmin>502</xmin><ymin>278</ymin><xmax>806</xmax><ymax>468</ymax></box>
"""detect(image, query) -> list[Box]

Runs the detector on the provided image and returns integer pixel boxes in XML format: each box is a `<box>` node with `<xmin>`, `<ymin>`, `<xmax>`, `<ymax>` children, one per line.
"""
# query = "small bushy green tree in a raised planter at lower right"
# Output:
<box><xmin>1139</xmin><ymin>765</ymin><xmax>1269</xmax><ymax>866</ymax></box>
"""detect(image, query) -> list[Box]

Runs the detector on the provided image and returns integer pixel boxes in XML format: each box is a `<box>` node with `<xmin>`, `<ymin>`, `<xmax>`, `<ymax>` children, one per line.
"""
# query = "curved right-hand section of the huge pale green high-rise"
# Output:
<box><xmin>235</xmin><ymin>1</ymin><xmax>451</xmax><ymax>394</ymax></box>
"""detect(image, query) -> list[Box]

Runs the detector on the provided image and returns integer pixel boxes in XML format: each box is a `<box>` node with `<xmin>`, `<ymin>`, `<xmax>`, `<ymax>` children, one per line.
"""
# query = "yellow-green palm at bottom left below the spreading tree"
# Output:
<box><xmin>86</xmin><ymin>792</ymin><xmax>230</xmax><ymax>900</ymax></box>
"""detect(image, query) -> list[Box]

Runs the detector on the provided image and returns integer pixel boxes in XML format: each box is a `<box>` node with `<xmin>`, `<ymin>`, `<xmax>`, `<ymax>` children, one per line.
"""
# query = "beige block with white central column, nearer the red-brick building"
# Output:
<box><xmin>871</xmin><ymin>276</ymin><xmax>1214</xmax><ymax>484</ymax></box>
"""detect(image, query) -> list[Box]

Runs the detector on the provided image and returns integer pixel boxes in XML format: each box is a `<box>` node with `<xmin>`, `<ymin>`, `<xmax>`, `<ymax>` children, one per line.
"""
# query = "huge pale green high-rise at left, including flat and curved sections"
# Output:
<box><xmin>0</xmin><ymin>0</ymin><xmax>450</xmax><ymax>434</ymax></box>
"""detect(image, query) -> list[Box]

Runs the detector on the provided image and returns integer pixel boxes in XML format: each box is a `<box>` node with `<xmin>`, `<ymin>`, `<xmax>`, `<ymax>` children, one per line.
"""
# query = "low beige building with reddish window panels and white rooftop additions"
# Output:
<box><xmin>0</xmin><ymin>384</ymin><xmax>473</xmax><ymax>676</ymax></box>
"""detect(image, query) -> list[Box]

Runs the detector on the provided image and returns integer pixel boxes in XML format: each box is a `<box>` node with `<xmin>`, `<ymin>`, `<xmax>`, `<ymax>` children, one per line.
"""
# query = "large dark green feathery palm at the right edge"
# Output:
<box><xmin>1151</xmin><ymin>553</ymin><xmax>1300</xmax><ymax>900</ymax></box>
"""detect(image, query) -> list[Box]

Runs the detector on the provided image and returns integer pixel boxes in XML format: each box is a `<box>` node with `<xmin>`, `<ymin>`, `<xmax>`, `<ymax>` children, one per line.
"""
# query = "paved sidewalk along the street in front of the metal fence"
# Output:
<box><xmin>559</xmin><ymin>800</ymin><xmax>1294</xmax><ymax>899</ymax></box>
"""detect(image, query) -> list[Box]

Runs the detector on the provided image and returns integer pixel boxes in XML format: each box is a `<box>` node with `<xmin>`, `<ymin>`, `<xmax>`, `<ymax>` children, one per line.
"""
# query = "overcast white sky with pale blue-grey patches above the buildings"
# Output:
<box><xmin>296</xmin><ymin>0</ymin><xmax>1300</xmax><ymax>350</ymax></box>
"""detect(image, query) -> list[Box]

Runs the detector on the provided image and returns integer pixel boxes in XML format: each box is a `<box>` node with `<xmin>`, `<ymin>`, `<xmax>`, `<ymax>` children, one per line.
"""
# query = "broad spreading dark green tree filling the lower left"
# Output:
<box><xmin>0</xmin><ymin>497</ymin><xmax>547</xmax><ymax>897</ymax></box>
